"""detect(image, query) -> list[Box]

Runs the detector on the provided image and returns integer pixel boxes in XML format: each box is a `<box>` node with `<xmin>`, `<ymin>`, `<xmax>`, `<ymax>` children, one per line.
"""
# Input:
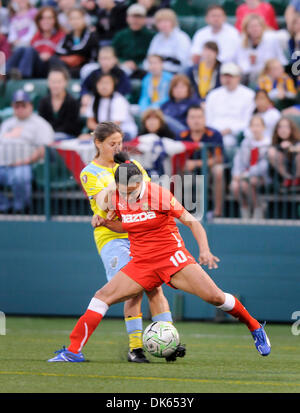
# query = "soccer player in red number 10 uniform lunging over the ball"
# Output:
<box><xmin>49</xmin><ymin>154</ymin><xmax>271</xmax><ymax>362</ymax></box>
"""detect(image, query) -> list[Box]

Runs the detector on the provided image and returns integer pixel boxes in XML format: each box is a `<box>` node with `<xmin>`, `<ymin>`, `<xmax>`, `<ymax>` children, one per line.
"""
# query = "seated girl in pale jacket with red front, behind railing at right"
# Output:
<box><xmin>230</xmin><ymin>115</ymin><xmax>270</xmax><ymax>219</ymax></box>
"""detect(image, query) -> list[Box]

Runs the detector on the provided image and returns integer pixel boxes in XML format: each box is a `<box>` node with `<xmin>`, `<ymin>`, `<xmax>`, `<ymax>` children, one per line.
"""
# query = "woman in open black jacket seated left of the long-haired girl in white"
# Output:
<box><xmin>38</xmin><ymin>68</ymin><xmax>81</xmax><ymax>140</ymax></box>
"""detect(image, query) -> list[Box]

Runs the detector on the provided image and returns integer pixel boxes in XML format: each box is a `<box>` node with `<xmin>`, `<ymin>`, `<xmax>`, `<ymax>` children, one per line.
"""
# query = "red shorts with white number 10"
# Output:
<box><xmin>121</xmin><ymin>247</ymin><xmax>196</xmax><ymax>291</ymax></box>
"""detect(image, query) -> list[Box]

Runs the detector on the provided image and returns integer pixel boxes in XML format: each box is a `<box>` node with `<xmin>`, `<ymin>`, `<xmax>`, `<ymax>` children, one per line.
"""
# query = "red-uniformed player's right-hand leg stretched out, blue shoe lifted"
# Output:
<box><xmin>171</xmin><ymin>264</ymin><xmax>271</xmax><ymax>356</ymax></box>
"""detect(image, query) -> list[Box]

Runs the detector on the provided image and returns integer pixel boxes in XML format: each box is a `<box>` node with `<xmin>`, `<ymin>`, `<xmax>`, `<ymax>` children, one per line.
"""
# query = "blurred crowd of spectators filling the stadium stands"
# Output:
<box><xmin>0</xmin><ymin>0</ymin><xmax>300</xmax><ymax>218</ymax></box>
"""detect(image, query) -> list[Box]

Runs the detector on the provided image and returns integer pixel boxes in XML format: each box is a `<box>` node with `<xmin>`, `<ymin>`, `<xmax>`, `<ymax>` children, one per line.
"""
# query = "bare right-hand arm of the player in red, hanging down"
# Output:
<box><xmin>178</xmin><ymin>209</ymin><xmax>220</xmax><ymax>269</ymax></box>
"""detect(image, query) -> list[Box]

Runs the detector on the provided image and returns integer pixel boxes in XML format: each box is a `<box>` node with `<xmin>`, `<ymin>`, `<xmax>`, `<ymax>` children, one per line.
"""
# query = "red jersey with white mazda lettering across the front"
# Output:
<box><xmin>116</xmin><ymin>182</ymin><xmax>184</xmax><ymax>265</ymax></box>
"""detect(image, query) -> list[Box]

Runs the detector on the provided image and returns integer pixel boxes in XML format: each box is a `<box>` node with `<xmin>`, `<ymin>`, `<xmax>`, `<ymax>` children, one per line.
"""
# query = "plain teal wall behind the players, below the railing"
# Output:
<box><xmin>0</xmin><ymin>221</ymin><xmax>300</xmax><ymax>322</ymax></box>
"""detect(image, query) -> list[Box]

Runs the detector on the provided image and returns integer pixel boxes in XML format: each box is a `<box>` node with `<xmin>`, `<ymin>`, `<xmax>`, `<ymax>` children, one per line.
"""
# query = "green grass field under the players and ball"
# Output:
<box><xmin>0</xmin><ymin>317</ymin><xmax>300</xmax><ymax>393</ymax></box>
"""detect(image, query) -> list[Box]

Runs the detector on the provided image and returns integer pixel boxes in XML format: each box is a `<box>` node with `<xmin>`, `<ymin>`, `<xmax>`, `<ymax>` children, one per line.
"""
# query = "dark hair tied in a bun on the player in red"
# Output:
<box><xmin>114</xmin><ymin>151</ymin><xmax>143</xmax><ymax>186</ymax></box>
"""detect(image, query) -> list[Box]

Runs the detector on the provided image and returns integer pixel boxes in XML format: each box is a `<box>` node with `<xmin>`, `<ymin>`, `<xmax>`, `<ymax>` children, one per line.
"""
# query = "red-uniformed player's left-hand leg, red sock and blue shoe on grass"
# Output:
<box><xmin>49</xmin><ymin>271</ymin><xmax>143</xmax><ymax>362</ymax></box>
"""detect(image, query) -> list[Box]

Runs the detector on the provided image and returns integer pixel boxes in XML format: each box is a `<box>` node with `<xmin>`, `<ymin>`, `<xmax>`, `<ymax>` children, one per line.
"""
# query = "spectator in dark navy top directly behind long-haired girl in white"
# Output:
<box><xmin>81</xmin><ymin>46</ymin><xmax>131</xmax><ymax>96</ymax></box>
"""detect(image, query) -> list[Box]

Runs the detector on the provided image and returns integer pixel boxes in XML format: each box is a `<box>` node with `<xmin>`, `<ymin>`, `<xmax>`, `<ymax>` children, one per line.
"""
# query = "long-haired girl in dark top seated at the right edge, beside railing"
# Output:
<box><xmin>268</xmin><ymin>117</ymin><xmax>300</xmax><ymax>190</ymax></box>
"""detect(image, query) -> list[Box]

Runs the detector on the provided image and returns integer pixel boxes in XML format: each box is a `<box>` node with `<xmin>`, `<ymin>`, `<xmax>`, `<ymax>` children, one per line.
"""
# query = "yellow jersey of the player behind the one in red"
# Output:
<box><xmin>80</xmin><ymin>160</ymin><xmax>150</xmax><ymax>253</ymax></box>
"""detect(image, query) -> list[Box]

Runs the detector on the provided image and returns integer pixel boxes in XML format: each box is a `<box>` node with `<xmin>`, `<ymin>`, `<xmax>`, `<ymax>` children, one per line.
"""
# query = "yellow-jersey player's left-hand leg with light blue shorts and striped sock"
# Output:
<box><xmin>100</xmin><ymin>238</ymin><xmax>147</xmax><ymax>363</ymax></box>
